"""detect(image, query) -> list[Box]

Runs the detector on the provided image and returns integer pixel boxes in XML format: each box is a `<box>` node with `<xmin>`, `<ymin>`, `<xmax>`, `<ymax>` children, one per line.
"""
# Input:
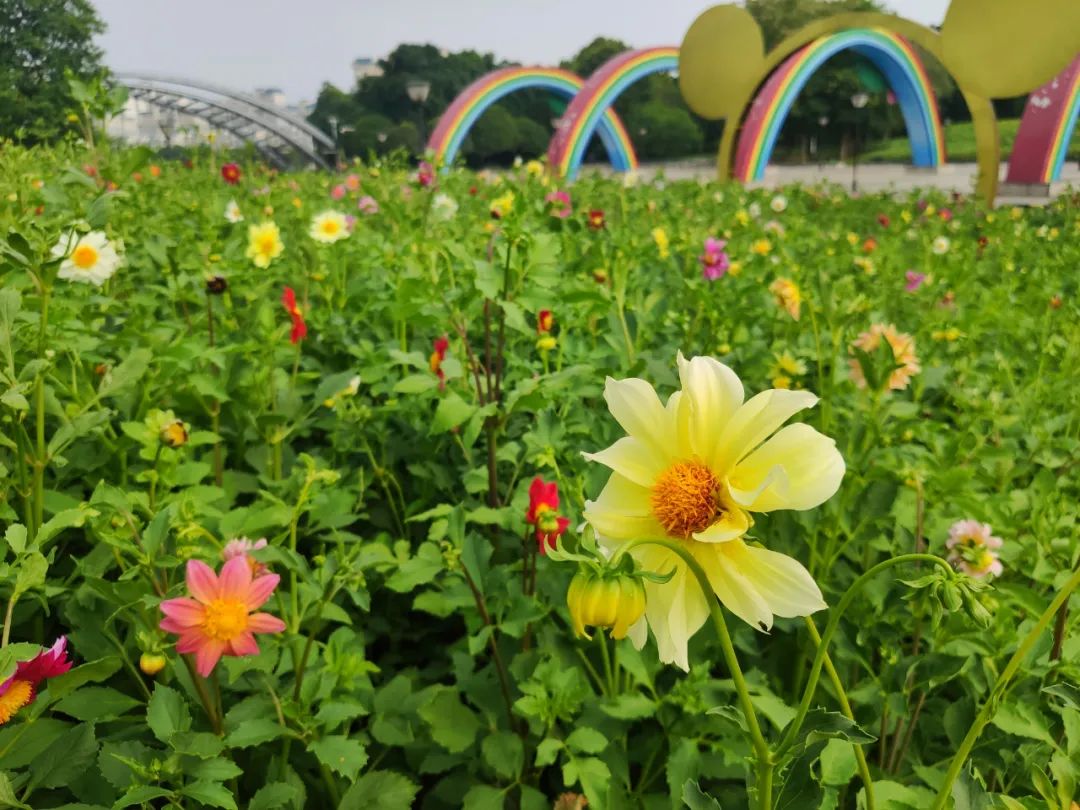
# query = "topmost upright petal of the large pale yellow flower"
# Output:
<box><xmin>678</xmin><ymin>352</ymin><xmax>744</xmax><ymax>460</ymax></box>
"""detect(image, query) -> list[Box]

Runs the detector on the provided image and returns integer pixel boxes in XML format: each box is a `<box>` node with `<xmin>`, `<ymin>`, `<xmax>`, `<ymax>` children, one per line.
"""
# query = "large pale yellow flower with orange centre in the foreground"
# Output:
<box><xmin>584</xmin><ymin>353</ymin><xmax>845</xmax><ymax>670</ymax></box>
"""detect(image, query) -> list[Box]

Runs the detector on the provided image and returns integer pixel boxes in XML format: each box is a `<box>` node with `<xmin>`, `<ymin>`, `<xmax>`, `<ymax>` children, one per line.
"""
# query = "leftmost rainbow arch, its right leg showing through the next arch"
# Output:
<box><xmin>428</xmin><ymin>67</ymin><xmax>637</xmax><ymax>172</ymax></box>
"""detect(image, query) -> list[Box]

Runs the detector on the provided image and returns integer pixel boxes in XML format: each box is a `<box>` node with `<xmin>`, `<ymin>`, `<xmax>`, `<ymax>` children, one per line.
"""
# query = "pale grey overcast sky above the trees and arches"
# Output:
<box><xmin>92</xmin><ymin>0</ymin><xmax>948</xmax><ymax>103</ymax></box>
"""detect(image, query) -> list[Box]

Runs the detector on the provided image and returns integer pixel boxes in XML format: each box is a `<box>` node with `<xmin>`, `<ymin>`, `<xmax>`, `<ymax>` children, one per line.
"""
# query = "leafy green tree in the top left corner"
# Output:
<box><xmin>0</xmin><ymin>0</ymin><xmax>105</xmax><ymax>143</ymax></box>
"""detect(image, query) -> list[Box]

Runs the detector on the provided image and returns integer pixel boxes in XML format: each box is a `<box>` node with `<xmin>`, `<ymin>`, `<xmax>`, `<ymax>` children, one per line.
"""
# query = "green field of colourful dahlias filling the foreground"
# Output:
<box><xmin>0</xmin><ymin>145</ymin><xmax>1080</xmax><ymax>810</ymax></box>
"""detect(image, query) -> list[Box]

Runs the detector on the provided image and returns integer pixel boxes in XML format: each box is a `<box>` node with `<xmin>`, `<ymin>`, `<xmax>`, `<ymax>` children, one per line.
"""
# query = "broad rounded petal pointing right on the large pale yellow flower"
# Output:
<box><xmin>728</xmin><ymin>423</ymin><xmax>846</xmax><ymax>512</ymax></box>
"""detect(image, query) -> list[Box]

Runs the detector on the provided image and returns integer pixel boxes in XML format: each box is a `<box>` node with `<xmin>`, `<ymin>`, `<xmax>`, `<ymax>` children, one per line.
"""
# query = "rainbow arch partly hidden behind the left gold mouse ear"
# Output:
<box><xmin>548</xmin><ymin>46</ymin><xmax>678</xmax><ymax>179</ymax></box>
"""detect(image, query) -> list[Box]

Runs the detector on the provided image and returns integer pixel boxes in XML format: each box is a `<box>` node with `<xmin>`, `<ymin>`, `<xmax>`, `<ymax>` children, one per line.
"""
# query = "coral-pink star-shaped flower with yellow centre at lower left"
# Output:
<box><xmin>159</xmin><ymin>555</ymin><xmax>285</xmax><ymax>678</ymax></box>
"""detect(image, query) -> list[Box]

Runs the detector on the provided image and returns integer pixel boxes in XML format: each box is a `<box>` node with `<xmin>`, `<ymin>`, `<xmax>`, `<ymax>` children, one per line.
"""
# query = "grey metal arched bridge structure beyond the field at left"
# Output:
<box><xmin>114</xmin><ymin>73</ymin><xmax>336</xmax><ymax>168</ymax></box>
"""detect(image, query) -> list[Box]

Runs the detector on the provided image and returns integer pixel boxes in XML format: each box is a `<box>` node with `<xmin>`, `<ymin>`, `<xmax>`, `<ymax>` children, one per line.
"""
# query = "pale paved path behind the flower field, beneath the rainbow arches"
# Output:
<box><xmin>597</xmin><ymin>159</ymin><xmax>1080</xmax><ymax>205</ymax></box>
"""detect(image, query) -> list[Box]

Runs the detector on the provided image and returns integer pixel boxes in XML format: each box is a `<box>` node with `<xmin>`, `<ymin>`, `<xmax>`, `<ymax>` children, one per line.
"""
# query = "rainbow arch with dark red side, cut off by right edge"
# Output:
<box><xmin>1005</xmin><ymin>55</ymin><xmax>1080</xmax><ymax>186</ymax></box>
